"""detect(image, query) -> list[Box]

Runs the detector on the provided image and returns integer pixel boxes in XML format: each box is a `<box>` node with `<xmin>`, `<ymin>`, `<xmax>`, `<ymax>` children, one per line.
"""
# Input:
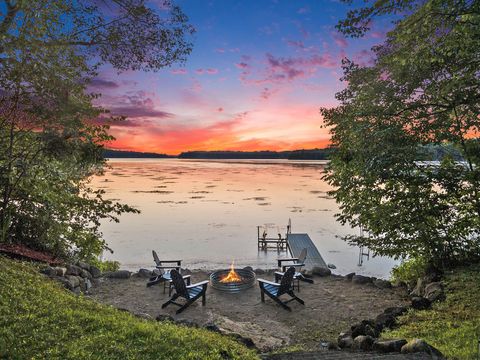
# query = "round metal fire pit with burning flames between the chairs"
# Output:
<box><xmin>210</xmin><ymin>264</ymin><xmax>255</xmax><ymax>293</ymax></box>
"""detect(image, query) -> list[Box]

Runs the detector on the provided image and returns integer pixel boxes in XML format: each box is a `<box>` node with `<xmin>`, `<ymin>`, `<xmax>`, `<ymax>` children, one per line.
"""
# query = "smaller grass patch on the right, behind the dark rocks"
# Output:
<box><xmin>382</xmin><ymin>264</ymin><xmax>480</xmax><ymax>360</ymax></box>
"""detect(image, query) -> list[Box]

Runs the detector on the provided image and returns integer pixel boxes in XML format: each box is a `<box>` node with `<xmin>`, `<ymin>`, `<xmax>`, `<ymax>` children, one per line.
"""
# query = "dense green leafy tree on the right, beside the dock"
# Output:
<box><xmin>321</xmin><ymin>0</ymin><xmax>480</xmax><ymax>265</ymax></box>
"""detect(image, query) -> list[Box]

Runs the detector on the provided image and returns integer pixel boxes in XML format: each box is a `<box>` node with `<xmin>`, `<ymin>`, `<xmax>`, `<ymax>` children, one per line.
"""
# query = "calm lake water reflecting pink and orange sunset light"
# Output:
<box><xmin>92</xmin><ymin>159</ymin><xmax>395</xmax><ymax>277</ymax></box>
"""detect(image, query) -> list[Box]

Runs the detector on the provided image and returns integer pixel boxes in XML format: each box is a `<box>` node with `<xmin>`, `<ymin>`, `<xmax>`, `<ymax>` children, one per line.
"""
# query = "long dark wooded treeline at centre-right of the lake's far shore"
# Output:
<box><xmin>178</xmin><ymin>148</ymin><xmax>332</xmax><ymax>160</ymax></box>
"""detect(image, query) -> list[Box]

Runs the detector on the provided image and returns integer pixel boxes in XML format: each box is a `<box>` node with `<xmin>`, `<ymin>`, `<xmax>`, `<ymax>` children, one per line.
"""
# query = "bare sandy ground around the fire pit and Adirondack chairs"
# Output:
<box><xmin>91</xmin><ymin>272</ymin><xmax>406</xmax><ymax>350</ymax></box>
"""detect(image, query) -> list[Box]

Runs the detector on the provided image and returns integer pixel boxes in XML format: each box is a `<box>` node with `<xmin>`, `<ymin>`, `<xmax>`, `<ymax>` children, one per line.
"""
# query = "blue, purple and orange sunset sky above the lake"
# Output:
<box><xmin>92</xmin><ymin>0</ymin><xmax>387</xmax><ymax>155</ymax></box>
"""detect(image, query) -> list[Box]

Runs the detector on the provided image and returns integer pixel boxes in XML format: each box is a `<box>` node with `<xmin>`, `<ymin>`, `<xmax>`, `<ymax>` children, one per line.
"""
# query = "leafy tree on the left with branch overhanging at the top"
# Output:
<box><xmin>0</xmin><ymin>0</ymin><xmax>193</xmax><ymax>258</ymax></box>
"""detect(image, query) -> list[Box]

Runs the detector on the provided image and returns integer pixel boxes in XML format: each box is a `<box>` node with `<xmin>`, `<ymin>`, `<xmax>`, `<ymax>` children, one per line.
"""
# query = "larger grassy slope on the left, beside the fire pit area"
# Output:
<box><xmin>0</xmin><ymin>256</ymin><xmax>258</xmax><ymax>360</ymax></box>
